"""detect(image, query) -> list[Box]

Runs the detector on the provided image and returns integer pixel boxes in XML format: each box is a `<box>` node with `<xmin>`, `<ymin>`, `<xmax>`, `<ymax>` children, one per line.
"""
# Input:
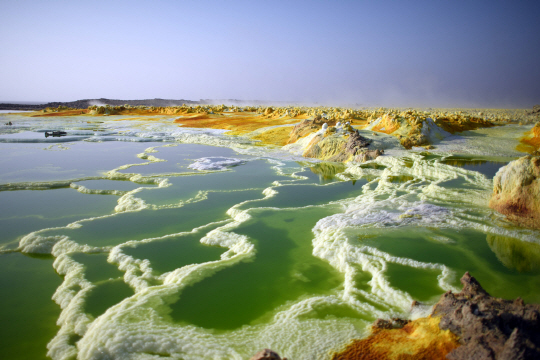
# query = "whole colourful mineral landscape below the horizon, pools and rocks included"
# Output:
<box><xmin>0</xmin><ymin>104</ymin><xmax>540</xmax><ymax>360</ymax></box>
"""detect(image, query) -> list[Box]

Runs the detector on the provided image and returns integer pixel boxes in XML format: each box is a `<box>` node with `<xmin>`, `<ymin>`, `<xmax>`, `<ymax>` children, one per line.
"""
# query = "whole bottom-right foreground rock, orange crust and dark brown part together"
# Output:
<box><xmin>333</xmin><ymin>272</ymin><xmax>540</xmax><ymax>360</ymax></box>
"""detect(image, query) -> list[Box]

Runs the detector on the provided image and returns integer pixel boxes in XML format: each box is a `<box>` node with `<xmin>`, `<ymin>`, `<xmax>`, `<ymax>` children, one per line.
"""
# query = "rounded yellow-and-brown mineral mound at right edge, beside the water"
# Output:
<box><xmin>489</xmin><ymin>156</ymin><xmax>540</xmax><ymax>229</ymax></box>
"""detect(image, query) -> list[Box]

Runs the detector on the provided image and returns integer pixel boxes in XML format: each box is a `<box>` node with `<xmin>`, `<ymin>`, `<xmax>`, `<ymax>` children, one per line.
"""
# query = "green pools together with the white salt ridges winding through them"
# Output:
<box><xmin>0</xmin><ymin>115</ymin><xmax>540</xmax><ymax>359</ymax></box>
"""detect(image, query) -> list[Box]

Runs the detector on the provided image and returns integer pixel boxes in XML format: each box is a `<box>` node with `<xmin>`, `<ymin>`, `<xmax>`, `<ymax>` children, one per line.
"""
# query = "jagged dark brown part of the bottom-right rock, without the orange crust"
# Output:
<box><xmin>432</xmin><ymin>272</ymin><xmax>540</xmax><ymax>360</ymax></box>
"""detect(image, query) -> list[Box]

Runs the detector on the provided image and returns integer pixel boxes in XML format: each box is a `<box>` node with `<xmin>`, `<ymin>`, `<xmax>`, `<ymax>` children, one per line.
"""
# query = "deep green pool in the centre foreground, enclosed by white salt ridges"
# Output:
<box><xmin>171</xmin><ymin>209</ymin><xmax>342</xmax><ymax>330</ymax></box>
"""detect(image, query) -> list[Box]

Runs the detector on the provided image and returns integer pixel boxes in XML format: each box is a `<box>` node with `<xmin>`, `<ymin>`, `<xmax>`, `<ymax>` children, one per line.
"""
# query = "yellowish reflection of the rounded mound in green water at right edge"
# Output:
<box><xmin>487</xmin><ymin>234</ymin><xmax>540</xmax><ymax>272</ymax></box>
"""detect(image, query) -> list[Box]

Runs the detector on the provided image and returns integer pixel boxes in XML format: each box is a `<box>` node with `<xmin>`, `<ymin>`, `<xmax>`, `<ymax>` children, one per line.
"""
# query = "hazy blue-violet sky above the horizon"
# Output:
<box><xmin>0</xmin><ymin>0</ymin><xmax>540</xmax><ymax>108</ymax></box>
